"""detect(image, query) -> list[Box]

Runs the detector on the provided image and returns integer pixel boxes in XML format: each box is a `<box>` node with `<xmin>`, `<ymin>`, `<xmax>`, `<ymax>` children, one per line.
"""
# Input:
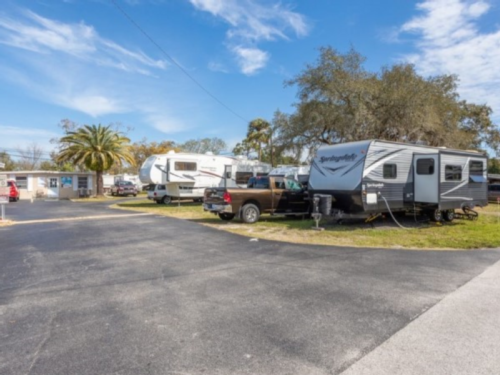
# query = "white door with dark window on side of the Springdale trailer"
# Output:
<box><xmin>413</xmin><ymin>154</ymin><xmax>439</xmax><ymax>204</ymax></box>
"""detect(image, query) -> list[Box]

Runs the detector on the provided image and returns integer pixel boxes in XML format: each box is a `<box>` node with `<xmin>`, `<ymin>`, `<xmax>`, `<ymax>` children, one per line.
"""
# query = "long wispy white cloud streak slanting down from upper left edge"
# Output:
<box><xmin>0</xmin><ymin>10</ymin><xmax>166</xmax><ymax>74</ymax></box>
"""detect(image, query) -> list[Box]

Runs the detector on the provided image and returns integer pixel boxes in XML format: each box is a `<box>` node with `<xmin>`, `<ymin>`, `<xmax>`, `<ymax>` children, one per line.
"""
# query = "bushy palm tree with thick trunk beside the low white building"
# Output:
<box><xmin>56</xmin><ymin>124</ymin><xmax>135</xmax><ymax>196</ymax></box>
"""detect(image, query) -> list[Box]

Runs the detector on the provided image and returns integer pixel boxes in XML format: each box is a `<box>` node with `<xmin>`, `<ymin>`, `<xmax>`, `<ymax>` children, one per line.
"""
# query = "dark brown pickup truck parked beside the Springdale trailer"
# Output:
<box><xmin>203</xmin><ymin>177</ymin><xmax>310</xmax><ymax>224</ymax></box>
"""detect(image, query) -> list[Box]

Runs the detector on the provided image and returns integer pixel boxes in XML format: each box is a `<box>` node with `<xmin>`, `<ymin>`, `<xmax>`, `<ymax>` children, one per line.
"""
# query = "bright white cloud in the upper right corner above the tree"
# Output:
<box><xmin>400</xmin><ymin>0</ymin><xmax>500</xmax><ymax>117</ymax></box>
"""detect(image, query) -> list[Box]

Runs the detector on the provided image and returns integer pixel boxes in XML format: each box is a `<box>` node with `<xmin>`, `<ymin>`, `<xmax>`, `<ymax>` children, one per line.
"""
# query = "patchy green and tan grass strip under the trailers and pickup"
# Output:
<box><xmin>116</xmin><ymin>200</ymin><xmax>500</xmax><ymax>249</ymax></box>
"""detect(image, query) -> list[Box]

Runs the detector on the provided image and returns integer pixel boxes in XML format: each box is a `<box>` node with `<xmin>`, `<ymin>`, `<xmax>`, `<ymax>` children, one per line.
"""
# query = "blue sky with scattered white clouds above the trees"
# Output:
<box><xmin>0</xmin><ymin>0</ymin><xmax>500</xmax><ymax>159</ymax></box>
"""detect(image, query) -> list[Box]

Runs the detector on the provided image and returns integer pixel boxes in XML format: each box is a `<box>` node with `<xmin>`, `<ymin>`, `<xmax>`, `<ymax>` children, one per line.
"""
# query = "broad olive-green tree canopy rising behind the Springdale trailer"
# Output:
<box><xmin>279</xmin><ymin>47</ymin><xmax>500</xmax><ymax>157</ymax></box>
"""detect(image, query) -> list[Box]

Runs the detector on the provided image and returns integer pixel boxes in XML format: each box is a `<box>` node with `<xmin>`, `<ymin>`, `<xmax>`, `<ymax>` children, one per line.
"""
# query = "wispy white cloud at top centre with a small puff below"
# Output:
<box><xmin>189</xmin><ymin>0</ymin><xmax>309</xmax><ymax>74</ymax></box>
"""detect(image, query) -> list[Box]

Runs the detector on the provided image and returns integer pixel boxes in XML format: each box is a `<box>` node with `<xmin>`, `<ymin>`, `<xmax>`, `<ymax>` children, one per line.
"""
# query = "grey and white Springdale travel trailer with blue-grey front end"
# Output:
<box><xmin>309</xmin><ymin>140</ymin><xmax>488</xmax><ymax>221</ymax></box>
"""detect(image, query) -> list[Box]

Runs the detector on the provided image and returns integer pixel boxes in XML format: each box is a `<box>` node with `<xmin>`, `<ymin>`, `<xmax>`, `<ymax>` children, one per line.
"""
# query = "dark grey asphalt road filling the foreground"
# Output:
<box><xmin>0</xmin><ymin>201</ymin><xmax>500</xmax><ymax>375</ymax></box>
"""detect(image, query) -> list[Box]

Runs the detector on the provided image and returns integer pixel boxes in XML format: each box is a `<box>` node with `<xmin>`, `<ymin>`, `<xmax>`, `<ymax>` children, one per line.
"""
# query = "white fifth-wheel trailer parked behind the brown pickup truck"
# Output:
<box><xmin>139</xmin><ymin>151</ymin><xmax>271</xmax><ymax>200</ymax></box>
